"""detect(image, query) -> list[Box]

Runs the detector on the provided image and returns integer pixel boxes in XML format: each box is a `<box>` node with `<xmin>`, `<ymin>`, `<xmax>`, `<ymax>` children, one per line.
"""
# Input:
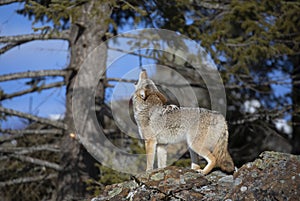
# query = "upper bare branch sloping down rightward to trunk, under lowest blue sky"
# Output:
<box><xmin>0</xmin><ymin>107</ymin><xmax>67</xmax><ymax>129</ymax></box>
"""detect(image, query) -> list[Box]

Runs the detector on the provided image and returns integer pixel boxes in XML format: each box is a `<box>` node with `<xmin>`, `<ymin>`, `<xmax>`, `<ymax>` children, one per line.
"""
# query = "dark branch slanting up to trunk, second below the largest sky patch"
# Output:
<box><xmin>0</xmin><ymin>81</ymin><xmax>65</xmax><ymax>101</ymax></box>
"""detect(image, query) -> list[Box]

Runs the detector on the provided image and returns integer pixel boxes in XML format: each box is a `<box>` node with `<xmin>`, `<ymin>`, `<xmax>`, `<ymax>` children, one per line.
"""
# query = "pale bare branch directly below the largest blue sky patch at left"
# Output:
<box><xmin>0</xmin><ymin>70</ymin><xmax>67</xmax><ymax>82</ymax></box>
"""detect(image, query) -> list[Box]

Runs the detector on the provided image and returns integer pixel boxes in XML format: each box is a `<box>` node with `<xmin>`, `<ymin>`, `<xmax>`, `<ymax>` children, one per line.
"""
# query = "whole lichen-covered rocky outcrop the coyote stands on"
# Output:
<box><xmin>92</xmin><ymin>152</ymin><xmax>300</xmax><ymax>201</ymax></box>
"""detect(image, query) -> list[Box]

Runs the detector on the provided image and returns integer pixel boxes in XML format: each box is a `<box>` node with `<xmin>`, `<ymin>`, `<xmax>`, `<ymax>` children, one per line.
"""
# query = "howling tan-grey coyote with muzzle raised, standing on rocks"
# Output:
<box><xmin>132</xmin><ymin>70</ymin><xmax>234</xmax><ymax>174</ymax></box>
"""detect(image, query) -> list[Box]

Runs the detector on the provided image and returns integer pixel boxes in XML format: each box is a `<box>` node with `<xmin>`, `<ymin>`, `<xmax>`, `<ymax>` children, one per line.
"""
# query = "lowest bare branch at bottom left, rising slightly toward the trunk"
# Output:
<box><xmin>0</xmin><ymin>173</ymin><xmax>57</xmax><ymax>187</ymax></box>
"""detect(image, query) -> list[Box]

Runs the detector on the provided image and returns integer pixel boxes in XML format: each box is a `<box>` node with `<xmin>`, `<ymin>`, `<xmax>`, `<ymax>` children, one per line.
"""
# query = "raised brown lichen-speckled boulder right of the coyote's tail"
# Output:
<box><xmin>227</xmin><ymin>152</ymin><xmax>300</xmax><ymax>200</ymax></box>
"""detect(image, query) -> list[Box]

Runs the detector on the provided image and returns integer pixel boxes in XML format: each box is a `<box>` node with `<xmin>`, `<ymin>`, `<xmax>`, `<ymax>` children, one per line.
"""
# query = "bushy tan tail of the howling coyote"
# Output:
<box><xmin>213</xmin><ymin>126</ymin><xmax>234</xmax><ymax>173</ymax></box>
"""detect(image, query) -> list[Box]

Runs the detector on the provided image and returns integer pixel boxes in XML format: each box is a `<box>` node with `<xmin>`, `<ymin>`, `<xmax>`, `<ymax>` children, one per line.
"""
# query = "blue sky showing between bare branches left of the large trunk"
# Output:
<box><xmin>0</xmin><ymin>3</ymin><xmax>69</xmax><ymax>128</ymax></box>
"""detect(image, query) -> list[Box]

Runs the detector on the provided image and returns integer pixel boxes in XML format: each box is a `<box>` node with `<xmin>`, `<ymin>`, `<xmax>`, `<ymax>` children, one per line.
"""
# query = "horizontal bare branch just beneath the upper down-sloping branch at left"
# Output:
<box><xmin>0</xmin><ymin>129</ymin><xmax>63</xmax><ymax>143</ymax></box>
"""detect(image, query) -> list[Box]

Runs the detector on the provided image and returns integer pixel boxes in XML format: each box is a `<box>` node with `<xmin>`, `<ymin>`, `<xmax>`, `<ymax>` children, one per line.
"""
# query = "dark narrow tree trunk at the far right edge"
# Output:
<box><xmin>292</xmin><ymin>56</ymin><xmax>300</xmax><ymax>154</ymax></box>
